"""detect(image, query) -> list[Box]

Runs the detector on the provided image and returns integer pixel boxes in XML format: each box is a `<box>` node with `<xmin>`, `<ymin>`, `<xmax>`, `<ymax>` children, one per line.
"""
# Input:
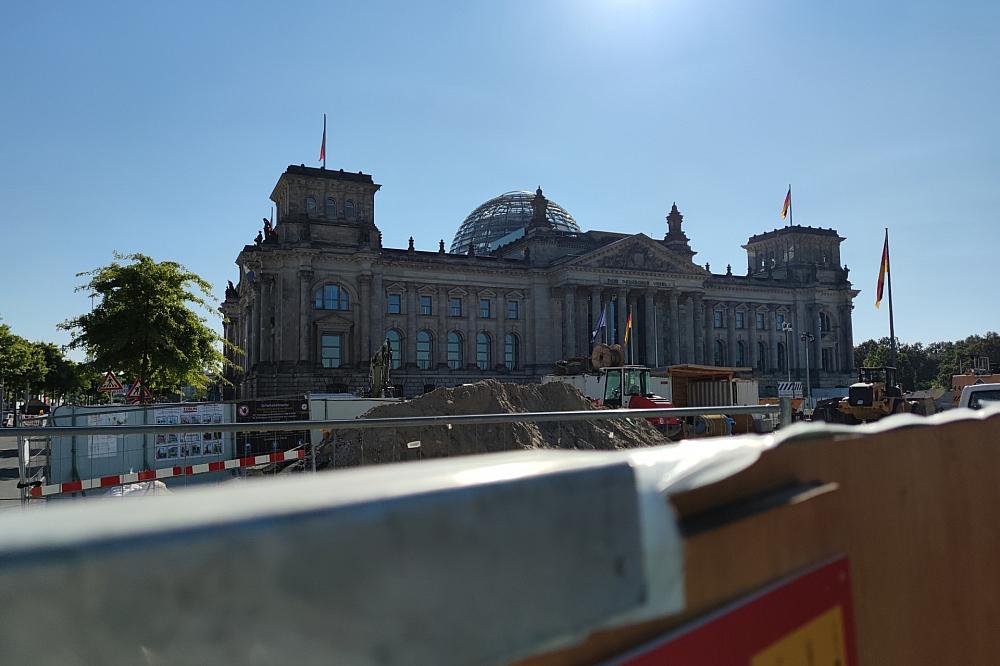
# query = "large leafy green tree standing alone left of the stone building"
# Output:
<box><xmin>60</xmin><ymin>253</ymin><xmax>225</xmax><ymax>393</ymax></box>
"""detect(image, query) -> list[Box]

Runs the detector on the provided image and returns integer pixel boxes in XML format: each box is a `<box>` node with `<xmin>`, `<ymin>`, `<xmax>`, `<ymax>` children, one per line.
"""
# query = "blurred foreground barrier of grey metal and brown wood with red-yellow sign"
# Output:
<box><xmin>0</xmin><ymin>406</ymin><xmax>1000</xmax><ymax>666</ymax></box>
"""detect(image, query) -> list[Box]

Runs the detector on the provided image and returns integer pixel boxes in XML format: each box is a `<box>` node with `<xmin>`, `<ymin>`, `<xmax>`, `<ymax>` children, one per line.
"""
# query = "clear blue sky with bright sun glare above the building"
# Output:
<box><xmin>0</xmin><ymin>0</ymin><xmax>1000</xmax><ymax>352</ymax></box>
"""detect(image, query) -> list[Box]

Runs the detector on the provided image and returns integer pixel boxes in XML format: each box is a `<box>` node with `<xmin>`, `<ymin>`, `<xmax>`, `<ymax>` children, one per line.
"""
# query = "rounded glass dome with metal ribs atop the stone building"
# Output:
<box><xmin>451</xmin><ymin>190</ymin><xmax>580</xmax><ymax>254</ymax></box>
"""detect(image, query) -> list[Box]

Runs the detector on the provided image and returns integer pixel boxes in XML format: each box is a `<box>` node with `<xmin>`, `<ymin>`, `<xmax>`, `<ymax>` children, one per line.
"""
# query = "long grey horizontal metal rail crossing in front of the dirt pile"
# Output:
<box><xmin>4</xmin><ymin>399</ymin><xmax>791</xmax><ymax>503</ymax></box>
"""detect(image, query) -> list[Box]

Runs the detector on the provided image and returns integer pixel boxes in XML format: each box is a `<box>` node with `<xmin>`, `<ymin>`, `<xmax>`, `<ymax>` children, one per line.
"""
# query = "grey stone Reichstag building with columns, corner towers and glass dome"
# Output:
<box><xmin>221</xmin><ymin>166</ymin><xmax>858</xmax><ymax>398</ymax></box>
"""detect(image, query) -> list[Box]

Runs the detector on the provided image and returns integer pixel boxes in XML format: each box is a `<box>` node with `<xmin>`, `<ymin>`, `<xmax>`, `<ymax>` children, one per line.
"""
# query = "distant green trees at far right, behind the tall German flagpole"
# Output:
<box><xmin>854</xmin><ymin>331</ymin><xmax>1000</xmax><ymax>390</ymax></box>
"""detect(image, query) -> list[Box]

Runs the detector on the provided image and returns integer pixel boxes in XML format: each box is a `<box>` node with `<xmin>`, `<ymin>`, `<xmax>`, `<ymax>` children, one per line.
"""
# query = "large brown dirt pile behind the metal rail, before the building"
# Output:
<box><xmin>297</xmin><ymin>379</ymin><xmax>668</xmax><ymax>468</ymax></box>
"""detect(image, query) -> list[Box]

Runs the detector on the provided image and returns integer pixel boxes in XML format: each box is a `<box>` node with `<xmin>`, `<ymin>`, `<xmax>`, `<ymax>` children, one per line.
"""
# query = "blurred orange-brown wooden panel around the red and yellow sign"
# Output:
<box><xmin>526</xmin><ymin>417</ymin><xmax>1000</xmax><ymax>665</ymax></box>
